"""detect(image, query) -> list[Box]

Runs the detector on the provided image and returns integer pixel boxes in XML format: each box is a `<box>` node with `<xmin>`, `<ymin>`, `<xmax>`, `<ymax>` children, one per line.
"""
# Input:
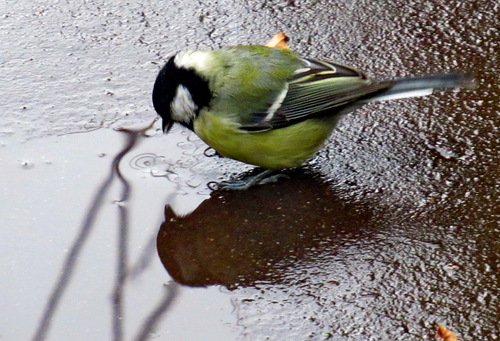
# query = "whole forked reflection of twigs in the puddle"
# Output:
<box><xmin>33</xmin><ymin>120</ymin><xmax>177</xmax><ymax>340</ymax></box>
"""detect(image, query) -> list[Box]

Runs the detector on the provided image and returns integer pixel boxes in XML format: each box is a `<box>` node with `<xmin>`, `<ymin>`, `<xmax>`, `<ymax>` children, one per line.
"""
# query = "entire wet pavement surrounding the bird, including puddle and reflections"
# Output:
<box><xmin>0</xmin><ymin>0</ymin><xmax>500</xmax><ymax>340</ymax></box>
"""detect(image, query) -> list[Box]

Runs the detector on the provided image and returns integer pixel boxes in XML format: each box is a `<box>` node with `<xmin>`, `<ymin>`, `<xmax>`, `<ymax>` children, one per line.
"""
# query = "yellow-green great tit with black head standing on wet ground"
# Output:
<box><xmin>152</xmin><ymin>34</ymin><xmax>473</xmax><ymax>189</ymax></box>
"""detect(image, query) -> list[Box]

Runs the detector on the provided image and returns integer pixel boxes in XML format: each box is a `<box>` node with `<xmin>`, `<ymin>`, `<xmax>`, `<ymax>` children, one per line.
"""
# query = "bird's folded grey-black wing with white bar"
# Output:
<box><xmin>240</xmin><ymin>59</ymin><xmax>389</xmax><ymax>131</ymax></box>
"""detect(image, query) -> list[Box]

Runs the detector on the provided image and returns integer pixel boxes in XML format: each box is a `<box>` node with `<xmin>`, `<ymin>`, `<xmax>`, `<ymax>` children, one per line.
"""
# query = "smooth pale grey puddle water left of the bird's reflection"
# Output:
<box><xmin>0</xmin><ymin>130</ymin><xmax>241</xmax><ymax>339</ymax></box>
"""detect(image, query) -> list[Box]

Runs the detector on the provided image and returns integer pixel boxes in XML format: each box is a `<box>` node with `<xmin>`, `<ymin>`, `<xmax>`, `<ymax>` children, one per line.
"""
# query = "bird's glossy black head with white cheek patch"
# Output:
<box><xmin>153</xmin><ymin>56</ymin><xmax>212</xmax><ymax>132</ymax></box>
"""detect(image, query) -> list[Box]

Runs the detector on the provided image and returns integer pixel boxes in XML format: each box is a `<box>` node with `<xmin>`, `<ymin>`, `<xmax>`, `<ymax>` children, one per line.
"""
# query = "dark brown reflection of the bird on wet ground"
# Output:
<box><xmin>157</xmin><ymin>172</ymin><xmax>373</xmax><ymax>288</ymax></box>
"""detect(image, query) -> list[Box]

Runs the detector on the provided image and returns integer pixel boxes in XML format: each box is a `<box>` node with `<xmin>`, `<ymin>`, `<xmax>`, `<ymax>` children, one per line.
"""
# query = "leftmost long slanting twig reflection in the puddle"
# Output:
<box><xmin>33</xmin><ymin>130</ymin><xmax>139</xmax><ymax>341</ymax></box>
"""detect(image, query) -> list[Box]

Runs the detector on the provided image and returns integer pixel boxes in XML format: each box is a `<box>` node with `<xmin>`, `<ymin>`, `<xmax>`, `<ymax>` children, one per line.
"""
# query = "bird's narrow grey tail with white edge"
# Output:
<box><xmin>364</xmin><ymin>73</ymin><xmax>475</xmax><ymax>103</ymax></box>
